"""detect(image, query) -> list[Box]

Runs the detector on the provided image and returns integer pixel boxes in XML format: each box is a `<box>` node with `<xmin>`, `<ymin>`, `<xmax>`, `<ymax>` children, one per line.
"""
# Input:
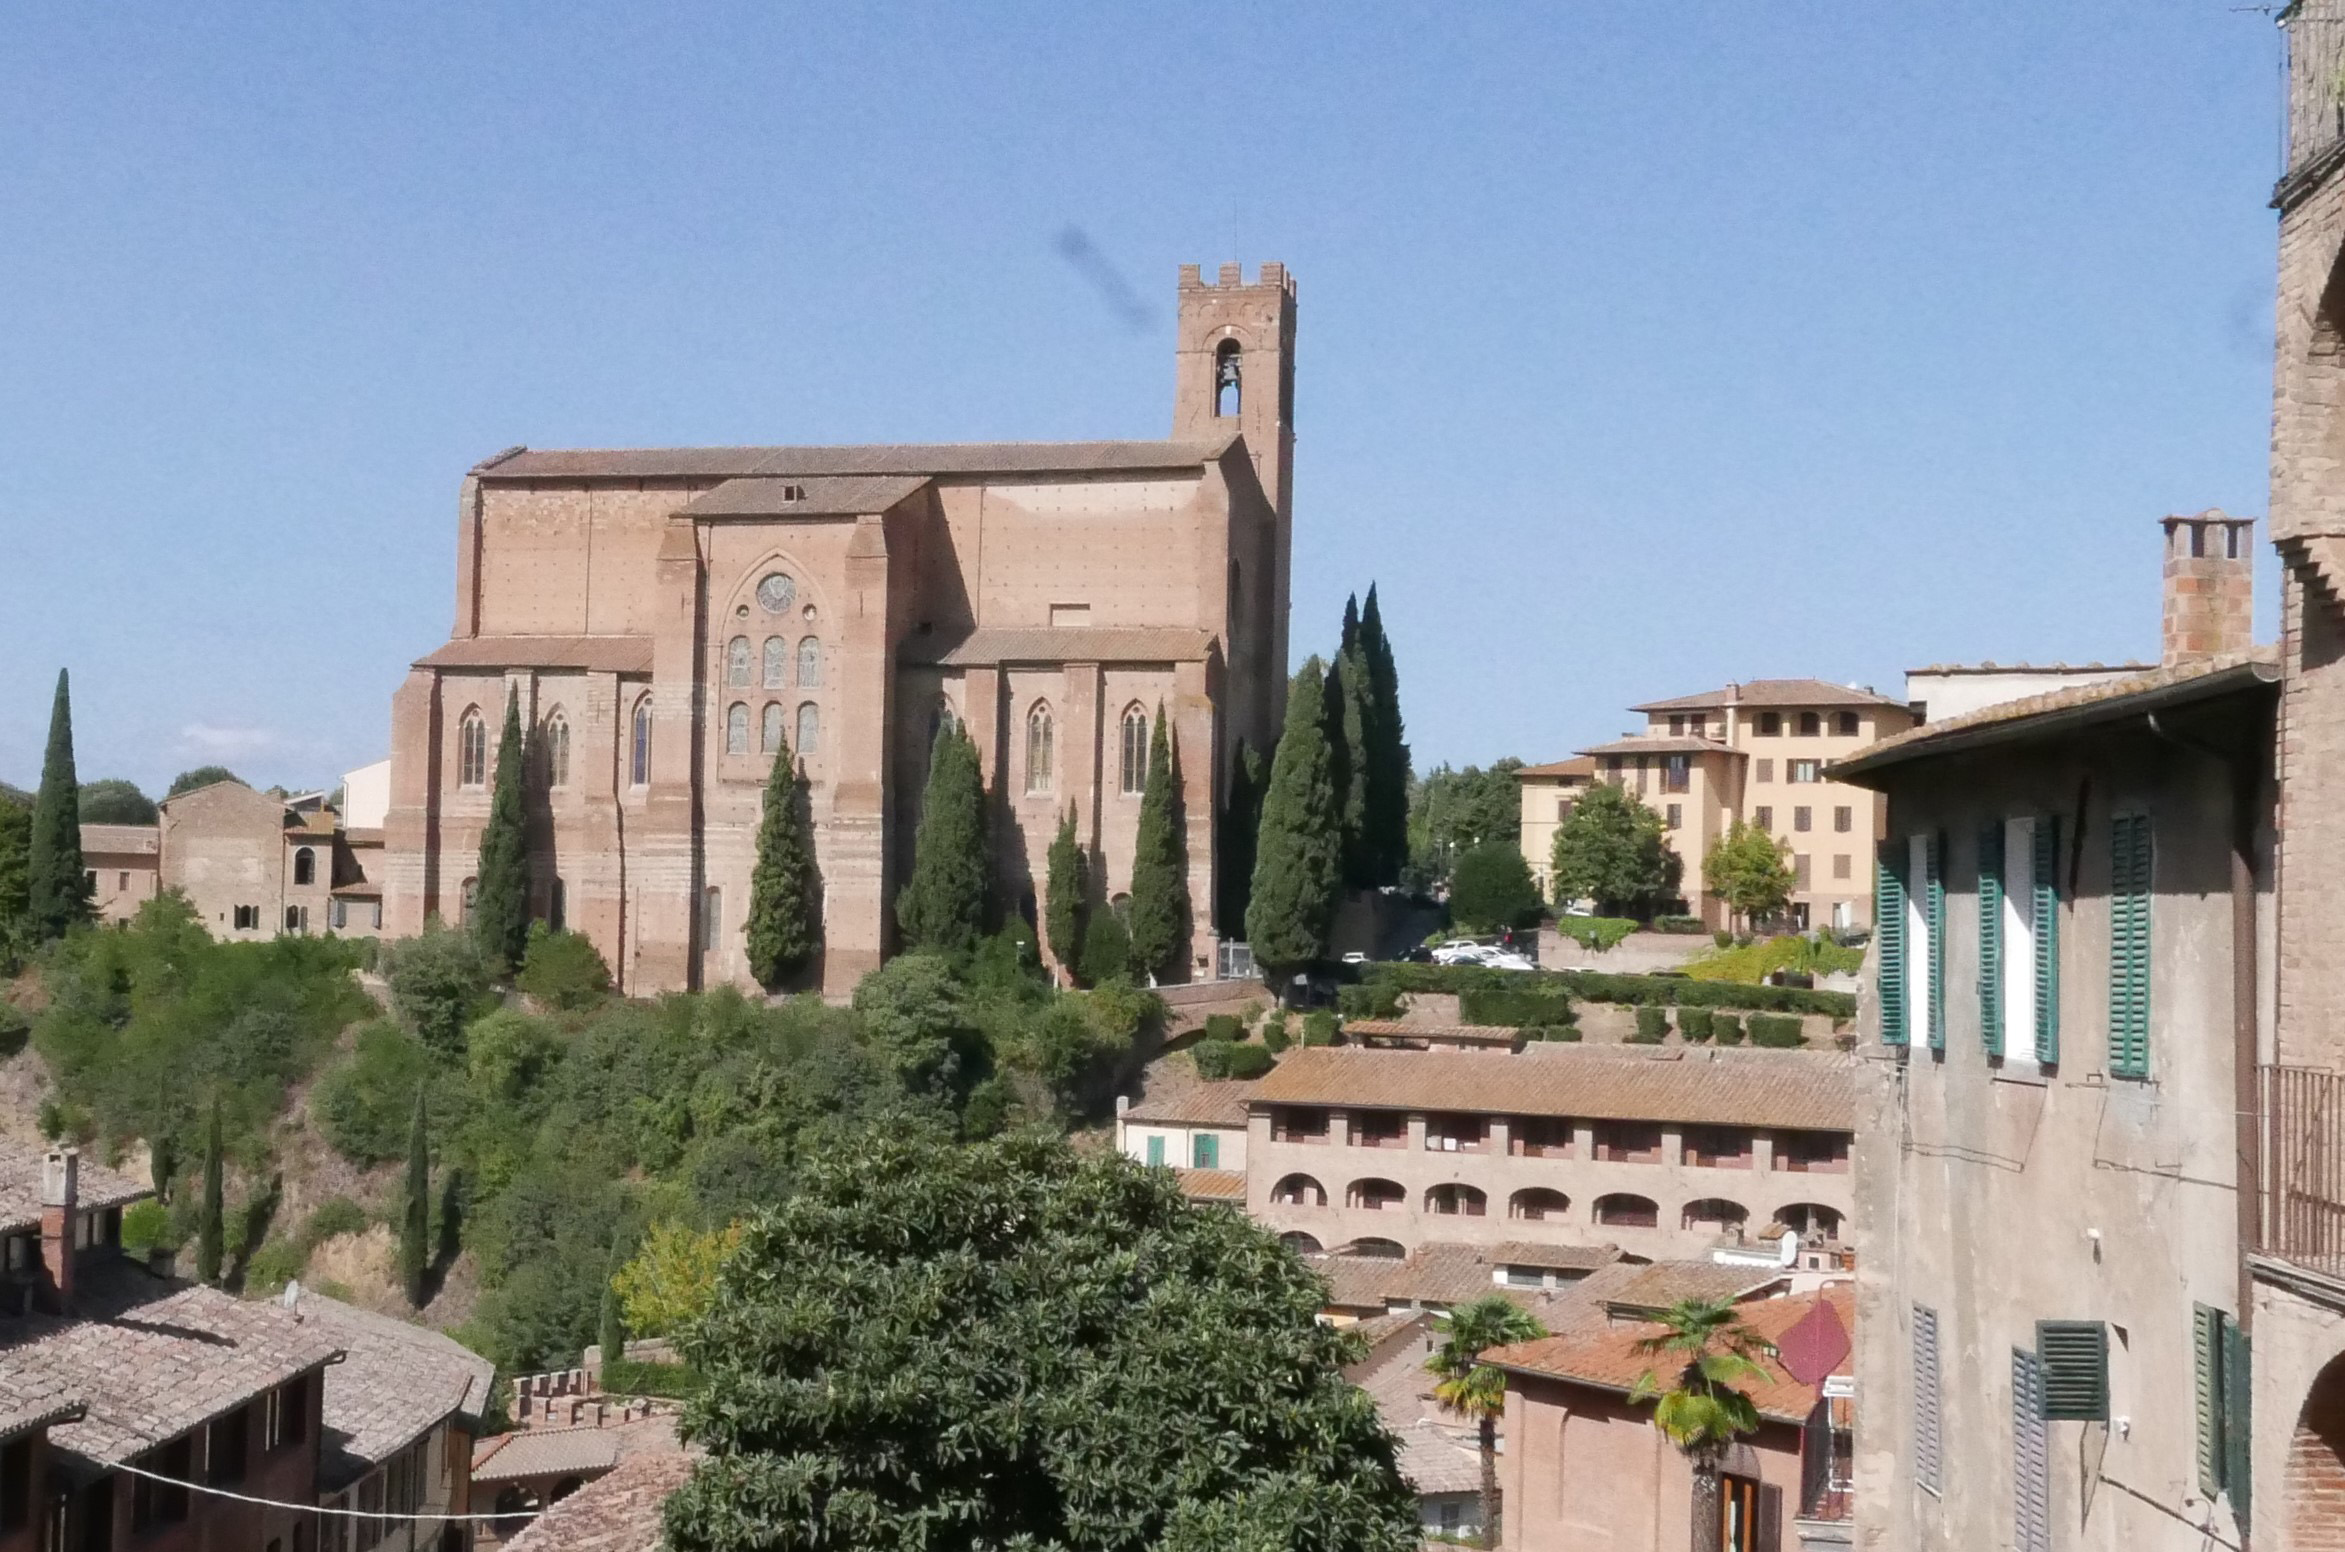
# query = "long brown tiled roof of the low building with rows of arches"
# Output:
<box><xmin>1252</xmin><ymin>1046</ymin><xmax>1857</xmax><ymax>1132</ymax></box>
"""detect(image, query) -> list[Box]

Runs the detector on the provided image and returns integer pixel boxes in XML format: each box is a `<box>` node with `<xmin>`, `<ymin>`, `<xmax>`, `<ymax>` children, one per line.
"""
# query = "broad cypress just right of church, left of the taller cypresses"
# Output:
<box><xmin>1245</xmin><ymin>656</ymin><xmax>1344</xmax><ymax>975</ymax></box>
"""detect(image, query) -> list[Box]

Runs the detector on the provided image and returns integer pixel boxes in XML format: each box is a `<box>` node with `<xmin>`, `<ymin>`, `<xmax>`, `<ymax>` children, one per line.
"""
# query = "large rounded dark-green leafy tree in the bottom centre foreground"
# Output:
<box><xmin>666</xmin><ymin>1135</ymin><xmax>1416</xmax><ymax>1552</ymax></box>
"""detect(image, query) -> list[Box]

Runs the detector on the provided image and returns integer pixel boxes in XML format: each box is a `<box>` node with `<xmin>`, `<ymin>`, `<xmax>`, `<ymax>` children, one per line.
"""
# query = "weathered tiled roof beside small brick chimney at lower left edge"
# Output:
<box><xmin>0</xmin><ymin>1265</ymin><xmax>342</xmax><ymax>1465</ymax></box>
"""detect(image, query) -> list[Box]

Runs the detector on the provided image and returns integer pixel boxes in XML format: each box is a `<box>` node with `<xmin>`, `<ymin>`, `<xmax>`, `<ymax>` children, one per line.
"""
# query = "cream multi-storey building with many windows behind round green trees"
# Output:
<box><xmin>1520</xmin><ymin>680</ymin><xmax>1916</xmax><ymax>928</ymax></box>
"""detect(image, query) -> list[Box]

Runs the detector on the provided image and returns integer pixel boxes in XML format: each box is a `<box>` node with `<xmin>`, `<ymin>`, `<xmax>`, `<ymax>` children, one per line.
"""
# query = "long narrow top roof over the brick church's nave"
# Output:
<box><xmin>474</xmin><ymin>438</ymin><xmax>1233</xmax><ymax>481</ymax></box>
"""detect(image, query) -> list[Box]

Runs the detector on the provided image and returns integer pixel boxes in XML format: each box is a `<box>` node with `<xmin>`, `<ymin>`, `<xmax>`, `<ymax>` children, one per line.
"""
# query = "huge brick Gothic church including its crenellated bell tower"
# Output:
<box><xmin>385</xmin><ymin>265</ymin><xmax>1294</xmax><ymax>994</ymax></box>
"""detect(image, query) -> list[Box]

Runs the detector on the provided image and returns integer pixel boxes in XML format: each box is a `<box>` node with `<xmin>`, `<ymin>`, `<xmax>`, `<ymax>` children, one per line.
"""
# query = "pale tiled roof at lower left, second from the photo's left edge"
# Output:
<box><xmin>298</xmin><ymin>1289</ymin><xmax>497</xmax><ymax>1493</ymax></box>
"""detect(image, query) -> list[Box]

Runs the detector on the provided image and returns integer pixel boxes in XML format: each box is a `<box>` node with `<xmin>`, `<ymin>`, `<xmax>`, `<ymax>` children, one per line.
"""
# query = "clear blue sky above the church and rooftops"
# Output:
<box><xmin>0</xmin><ymin>0</ymin><xmax>2279</xmax><ymax>788</ymax></box>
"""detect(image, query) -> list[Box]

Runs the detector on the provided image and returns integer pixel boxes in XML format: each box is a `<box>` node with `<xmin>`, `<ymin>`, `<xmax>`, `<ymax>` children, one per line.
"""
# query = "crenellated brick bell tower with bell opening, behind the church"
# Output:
<box><xmin>1173</xmin><ymin>263</ymin><xmax>1294</xmax><ymax>685</ymax></box>
